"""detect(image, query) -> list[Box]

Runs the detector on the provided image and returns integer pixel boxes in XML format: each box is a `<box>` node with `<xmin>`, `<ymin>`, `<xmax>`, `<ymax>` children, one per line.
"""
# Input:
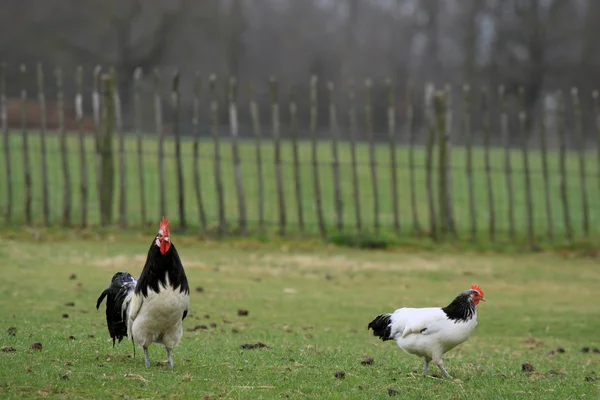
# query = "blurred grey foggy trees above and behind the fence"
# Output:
<box><xmin>0</xmin><ymin>0</ymin><xmax>600</xmax><ymax>145</ymax></box>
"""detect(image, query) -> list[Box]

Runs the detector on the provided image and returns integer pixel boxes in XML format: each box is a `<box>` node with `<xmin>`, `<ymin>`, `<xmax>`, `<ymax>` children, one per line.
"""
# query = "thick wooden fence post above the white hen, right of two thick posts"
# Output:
<box><xmin>434</xmin><ymin>92</ymin><xmax>451</xmax><ymax>236</ymax></box>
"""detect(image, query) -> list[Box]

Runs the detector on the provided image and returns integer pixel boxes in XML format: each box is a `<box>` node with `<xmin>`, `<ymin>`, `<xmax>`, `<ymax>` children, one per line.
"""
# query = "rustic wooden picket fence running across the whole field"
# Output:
<box><xmin>0</xmin><ymin>65</ymin><xmax>600</xmax><ymax>247</ymax></box>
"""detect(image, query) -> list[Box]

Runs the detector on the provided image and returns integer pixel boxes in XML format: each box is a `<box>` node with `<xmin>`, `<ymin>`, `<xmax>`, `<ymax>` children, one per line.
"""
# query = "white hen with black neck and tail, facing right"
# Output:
<box><xmin>367</xmin><ymin>285</ymin><xmax>485</xmax><ymax>378</ymax></box>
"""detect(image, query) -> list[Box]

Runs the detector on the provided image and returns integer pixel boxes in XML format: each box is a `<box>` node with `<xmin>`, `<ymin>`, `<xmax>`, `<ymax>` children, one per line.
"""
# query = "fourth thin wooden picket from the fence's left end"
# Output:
<box><xmin>55</xmin><ymin>67</ymin><xmax>71</xmax><ymax>226</ymax></box>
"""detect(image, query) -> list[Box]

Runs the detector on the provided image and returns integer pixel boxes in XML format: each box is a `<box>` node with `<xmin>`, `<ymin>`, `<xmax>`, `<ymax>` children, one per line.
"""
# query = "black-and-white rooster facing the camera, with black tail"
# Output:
<box><xmin>96</xmin><ymin>217</ymin><xmax>190</xmax><ymax>368</ymax></box>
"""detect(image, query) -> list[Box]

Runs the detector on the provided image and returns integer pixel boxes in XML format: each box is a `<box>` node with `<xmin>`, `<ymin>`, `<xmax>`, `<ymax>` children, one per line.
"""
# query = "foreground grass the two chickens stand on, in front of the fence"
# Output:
<box><xmin>0</xmin><ymin>233</ymin><xmax>600</xmax><ymax>399</ymax></box>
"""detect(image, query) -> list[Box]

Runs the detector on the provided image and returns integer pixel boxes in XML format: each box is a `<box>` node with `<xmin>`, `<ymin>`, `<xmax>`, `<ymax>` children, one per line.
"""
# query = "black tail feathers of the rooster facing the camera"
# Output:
<box><xmin>96</xmin><ymin>272</ymin><xmax>137</xmax><ymax>347</ymax></box>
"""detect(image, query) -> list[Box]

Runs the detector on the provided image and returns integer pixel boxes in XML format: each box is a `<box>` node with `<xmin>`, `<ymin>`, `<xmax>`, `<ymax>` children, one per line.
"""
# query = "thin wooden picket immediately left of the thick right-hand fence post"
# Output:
<box><xmin>425</xmin><ymin>83</ymin><xmax>438</xmax><ymax>240</ymax></box>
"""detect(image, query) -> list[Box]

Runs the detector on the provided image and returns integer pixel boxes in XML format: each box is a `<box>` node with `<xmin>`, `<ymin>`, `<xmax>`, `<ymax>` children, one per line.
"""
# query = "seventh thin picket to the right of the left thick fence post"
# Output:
<box><xmin>229</xmin><ymin>77</ymin><xmax>247</xmax><ymax>235</ymax></box>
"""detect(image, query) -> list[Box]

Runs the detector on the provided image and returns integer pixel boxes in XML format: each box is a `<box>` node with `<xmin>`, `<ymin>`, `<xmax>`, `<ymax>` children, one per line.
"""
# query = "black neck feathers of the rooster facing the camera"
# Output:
<box><xmin>135</xmin><ymin>241</ymin><xmax>190</xmax><ymax>297</ymax></box>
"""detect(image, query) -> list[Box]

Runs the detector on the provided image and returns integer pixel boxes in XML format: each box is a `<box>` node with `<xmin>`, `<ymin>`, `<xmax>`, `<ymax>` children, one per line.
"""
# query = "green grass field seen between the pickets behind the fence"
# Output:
<box><xmin>0</xmin><ymin>132</ymin><xmax>600</xmax><ymax>243</ymax></box>
